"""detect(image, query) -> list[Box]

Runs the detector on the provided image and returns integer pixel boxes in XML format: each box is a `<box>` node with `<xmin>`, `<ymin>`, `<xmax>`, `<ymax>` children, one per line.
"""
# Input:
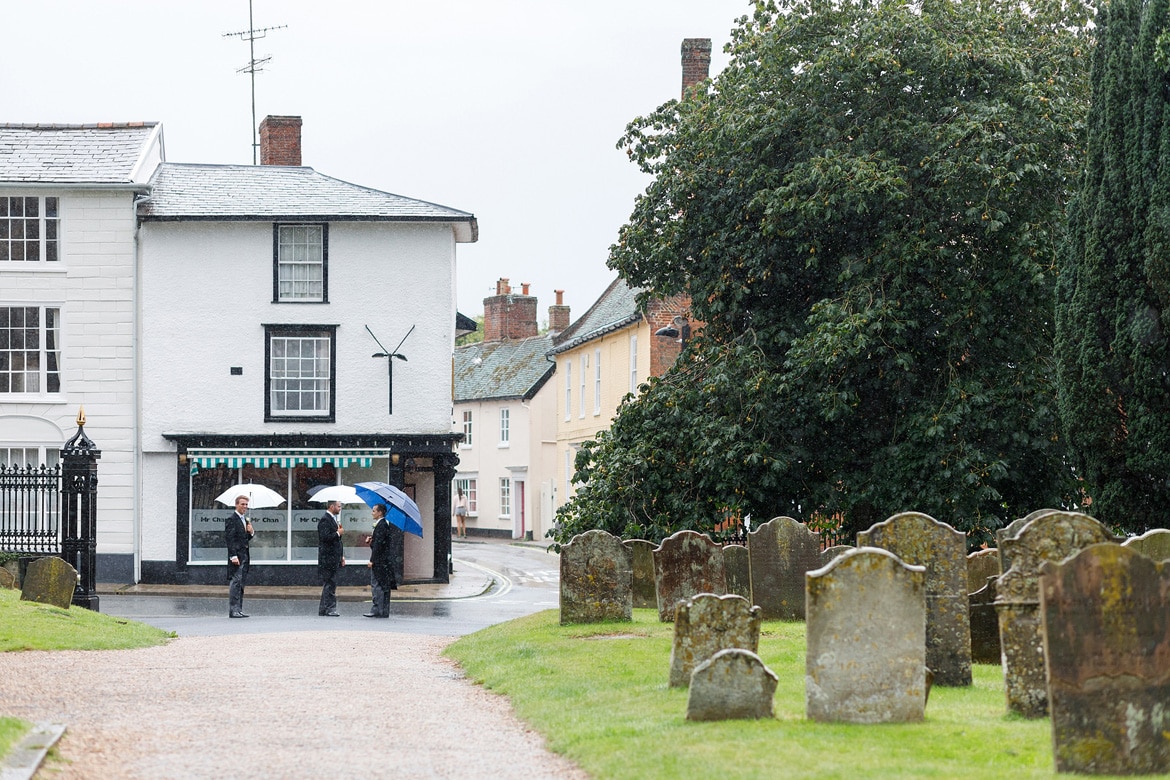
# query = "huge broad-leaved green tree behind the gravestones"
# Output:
<box><xmin>556</xmin><ymin>0</ymin><xmax>1088</xmax><ymax>549</ymax></box>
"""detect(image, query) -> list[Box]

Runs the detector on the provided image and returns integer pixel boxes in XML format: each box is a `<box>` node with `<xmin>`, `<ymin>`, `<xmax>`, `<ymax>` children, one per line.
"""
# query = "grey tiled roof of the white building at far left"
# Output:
<box><xmin>0</xmin><ymin>122</ymin><xmax>158</xmax><ymax>184</ymax></box>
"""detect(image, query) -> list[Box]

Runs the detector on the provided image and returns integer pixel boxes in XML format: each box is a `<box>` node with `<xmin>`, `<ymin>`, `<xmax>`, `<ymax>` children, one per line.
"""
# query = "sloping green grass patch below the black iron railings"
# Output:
<box><xmin>0</xmin><ymin>588</ymin><xmax>174</xmax><ymax>653</ymax></box>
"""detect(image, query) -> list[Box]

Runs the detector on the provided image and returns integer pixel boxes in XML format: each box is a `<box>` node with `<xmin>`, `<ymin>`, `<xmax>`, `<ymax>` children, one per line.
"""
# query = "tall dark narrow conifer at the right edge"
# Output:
<box><xmin>1057</xmin><ymin>0</ymin><xmax>1170</xmax><ymax>532</ymax></box>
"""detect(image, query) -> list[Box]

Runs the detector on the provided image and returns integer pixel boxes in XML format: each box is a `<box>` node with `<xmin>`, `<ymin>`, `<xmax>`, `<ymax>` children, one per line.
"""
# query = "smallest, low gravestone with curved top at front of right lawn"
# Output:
<box><xmin>687</xmin><ymin>648</ymin><xmax>779</xmax><ymax>720</ymax></box>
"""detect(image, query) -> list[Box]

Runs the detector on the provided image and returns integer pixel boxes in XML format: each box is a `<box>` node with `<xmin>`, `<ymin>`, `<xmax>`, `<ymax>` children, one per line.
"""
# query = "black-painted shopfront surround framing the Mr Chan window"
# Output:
<box><xmin>152</xmin><ymin>434</ymin><xmax>462</xmax><ymax>586</ymax></box>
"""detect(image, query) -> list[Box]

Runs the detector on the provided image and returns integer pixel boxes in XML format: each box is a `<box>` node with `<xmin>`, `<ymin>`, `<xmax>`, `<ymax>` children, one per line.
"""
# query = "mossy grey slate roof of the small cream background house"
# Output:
<box><xmin>455</xmin><ymin>336</ymin><xmax>556</xmax><ymax>402</ymax></box>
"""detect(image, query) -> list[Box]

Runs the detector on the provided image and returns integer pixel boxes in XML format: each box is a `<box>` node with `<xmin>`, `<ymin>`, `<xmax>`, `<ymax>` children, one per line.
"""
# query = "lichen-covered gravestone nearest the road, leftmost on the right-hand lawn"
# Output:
<box><xmin>560</xmin><ymin>530</ymin><xmax>633</xmax><ymax>626</ymax></box>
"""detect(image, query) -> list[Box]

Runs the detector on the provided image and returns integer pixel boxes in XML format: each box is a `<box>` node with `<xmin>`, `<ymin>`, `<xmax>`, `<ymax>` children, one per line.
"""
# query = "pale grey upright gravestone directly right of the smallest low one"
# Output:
<box><xmin>805</xmin><ymin>547</ymin><xmax>927</xmax><ymax>723</ymax></box>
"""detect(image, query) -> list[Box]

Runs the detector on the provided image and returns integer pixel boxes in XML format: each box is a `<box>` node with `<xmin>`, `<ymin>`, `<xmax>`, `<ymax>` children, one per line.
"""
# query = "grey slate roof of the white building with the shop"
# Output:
<box><xmin>138</xmin><ymin>163</ymin><xmax>479</xmax><ymax>242</ymax></box>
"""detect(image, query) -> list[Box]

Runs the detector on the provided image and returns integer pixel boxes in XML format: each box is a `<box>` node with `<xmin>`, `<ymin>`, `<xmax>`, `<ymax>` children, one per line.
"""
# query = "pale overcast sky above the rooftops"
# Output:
<box><xmin>0</xmin><ymin>0</ymin><xmax>750</xmax><ymax>319</ymax></box>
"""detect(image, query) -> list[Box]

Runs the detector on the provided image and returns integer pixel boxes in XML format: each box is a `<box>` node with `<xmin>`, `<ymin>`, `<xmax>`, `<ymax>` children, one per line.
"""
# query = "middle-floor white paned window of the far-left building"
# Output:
<box><xmin>0</xmin><ymin>304</ymin><xmax>63</xmax><ymax>399</ymax></box>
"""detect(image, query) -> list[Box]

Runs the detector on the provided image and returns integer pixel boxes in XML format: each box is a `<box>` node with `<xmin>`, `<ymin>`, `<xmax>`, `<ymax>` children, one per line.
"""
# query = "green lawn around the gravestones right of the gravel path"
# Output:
<box><xmin>446</xmin><ymin>609</ymin><xmax>1076</xmax><ymax>780</ymax></box>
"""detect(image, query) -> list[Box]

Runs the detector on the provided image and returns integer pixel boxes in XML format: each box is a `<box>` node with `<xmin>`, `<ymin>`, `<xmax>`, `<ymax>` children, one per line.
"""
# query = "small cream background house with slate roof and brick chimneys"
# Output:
<box><xmin>454</xmin><ymin>278</ymin><xmax>569</xmax><ymax>539</ymax></box>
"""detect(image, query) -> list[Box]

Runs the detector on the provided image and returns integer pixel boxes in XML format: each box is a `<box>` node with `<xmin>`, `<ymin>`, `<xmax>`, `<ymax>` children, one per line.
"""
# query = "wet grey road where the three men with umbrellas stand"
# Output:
<box><xmin>102</xmin><ymin>543</ymin><xmax>559</xmax><ymax>636</ymax></box>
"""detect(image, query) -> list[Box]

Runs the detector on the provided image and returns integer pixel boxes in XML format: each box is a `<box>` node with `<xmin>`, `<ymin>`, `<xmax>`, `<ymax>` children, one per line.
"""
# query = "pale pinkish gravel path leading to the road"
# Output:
<box><xmin>0</xmin><ymin>631</ymin><xmax>587</xmax><ymax>780</ymax></box>
